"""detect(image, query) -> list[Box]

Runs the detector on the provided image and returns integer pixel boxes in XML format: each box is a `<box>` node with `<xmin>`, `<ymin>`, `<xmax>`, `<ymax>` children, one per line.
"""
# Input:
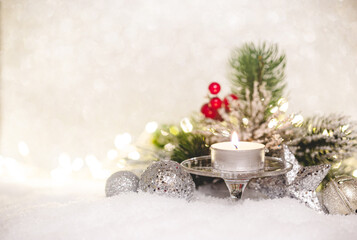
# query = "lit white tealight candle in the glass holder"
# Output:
<box><xmin>211</xmin><ymin>132</ymin><xmax>265</xmax><ymax>171</ymax></box>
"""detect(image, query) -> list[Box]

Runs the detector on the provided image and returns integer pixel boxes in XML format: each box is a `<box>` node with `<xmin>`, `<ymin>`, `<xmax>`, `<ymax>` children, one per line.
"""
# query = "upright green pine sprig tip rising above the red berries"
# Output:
<box><xmin>229</xmin><ymin>42</ymin><xmax>286</xmax><ymax>109</ymax></box>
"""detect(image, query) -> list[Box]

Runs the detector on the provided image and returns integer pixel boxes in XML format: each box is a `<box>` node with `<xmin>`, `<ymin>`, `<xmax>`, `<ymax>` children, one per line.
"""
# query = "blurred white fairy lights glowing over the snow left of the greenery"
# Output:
<box><xmin>0</xmin><ymin>121</ymin><xmax>158</xmax><ymax>184</ymax></box>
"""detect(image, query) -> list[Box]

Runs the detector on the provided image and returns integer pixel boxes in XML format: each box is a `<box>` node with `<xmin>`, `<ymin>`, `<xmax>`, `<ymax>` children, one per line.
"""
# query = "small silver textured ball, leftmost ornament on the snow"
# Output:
<box><xmin>105</xmin><ymin>171</ymin><xmax>139</xmax><ymax>197</ymax></box>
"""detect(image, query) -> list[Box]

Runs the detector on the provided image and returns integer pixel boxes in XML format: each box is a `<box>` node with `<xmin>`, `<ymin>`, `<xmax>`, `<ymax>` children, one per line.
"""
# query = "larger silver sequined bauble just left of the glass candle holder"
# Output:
<box><xmin>139</xmin><ymin>160</ymin><xmax>195</xmax><ymax>199</ymax></box>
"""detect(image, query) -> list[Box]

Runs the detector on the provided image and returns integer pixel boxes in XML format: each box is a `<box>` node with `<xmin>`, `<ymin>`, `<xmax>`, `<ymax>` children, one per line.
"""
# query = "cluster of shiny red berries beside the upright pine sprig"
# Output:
<box><xmin>201</xmin><ymin>82</ymin><xmax>238</xmax><ymax>120</ymax></box>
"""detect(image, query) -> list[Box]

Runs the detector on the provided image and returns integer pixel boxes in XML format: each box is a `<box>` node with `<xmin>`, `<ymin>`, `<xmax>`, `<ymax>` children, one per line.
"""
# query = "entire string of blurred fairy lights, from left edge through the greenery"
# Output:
<box><xmin>0</xmin><ymin>99</ymin><xmax>357</xmax><ymax>184</ymax></box>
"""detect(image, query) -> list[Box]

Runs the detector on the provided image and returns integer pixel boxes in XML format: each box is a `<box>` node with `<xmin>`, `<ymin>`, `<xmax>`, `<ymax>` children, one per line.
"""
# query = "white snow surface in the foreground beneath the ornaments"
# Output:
<box><xmin>0</xmin><ymin>183</ymin><xmax>357</xmax><ymax>240</ymax></box>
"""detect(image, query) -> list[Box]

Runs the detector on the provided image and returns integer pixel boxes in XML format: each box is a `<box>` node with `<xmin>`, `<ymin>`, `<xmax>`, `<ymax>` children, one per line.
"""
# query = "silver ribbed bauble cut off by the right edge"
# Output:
<box><xmin>321</xmin><ymin>176</ymin><xmax>357</xmax><ymax>215</ymax></box>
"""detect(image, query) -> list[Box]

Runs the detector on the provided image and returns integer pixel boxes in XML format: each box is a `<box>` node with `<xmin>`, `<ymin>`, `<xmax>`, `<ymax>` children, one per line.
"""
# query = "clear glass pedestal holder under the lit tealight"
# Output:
<box><xmin>181</xmin><ymin>156</ymin><xmax>292</xmax><ymax>200</ymax></box>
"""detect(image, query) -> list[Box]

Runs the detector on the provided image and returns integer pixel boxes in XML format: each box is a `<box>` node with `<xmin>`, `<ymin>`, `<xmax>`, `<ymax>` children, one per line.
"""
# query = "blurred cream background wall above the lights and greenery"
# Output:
<box><xmin>1</xmin><ymin>0</ymin><xmax>357</xmax><ymax>172</ymax></box>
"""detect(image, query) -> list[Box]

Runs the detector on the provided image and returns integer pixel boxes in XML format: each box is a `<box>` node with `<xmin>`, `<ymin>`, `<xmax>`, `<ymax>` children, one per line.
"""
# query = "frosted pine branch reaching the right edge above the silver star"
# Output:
<box><xmin>289</xmin><ymin>115</ymin><xmax>357</xmax><ymax>165</ymax></box>
